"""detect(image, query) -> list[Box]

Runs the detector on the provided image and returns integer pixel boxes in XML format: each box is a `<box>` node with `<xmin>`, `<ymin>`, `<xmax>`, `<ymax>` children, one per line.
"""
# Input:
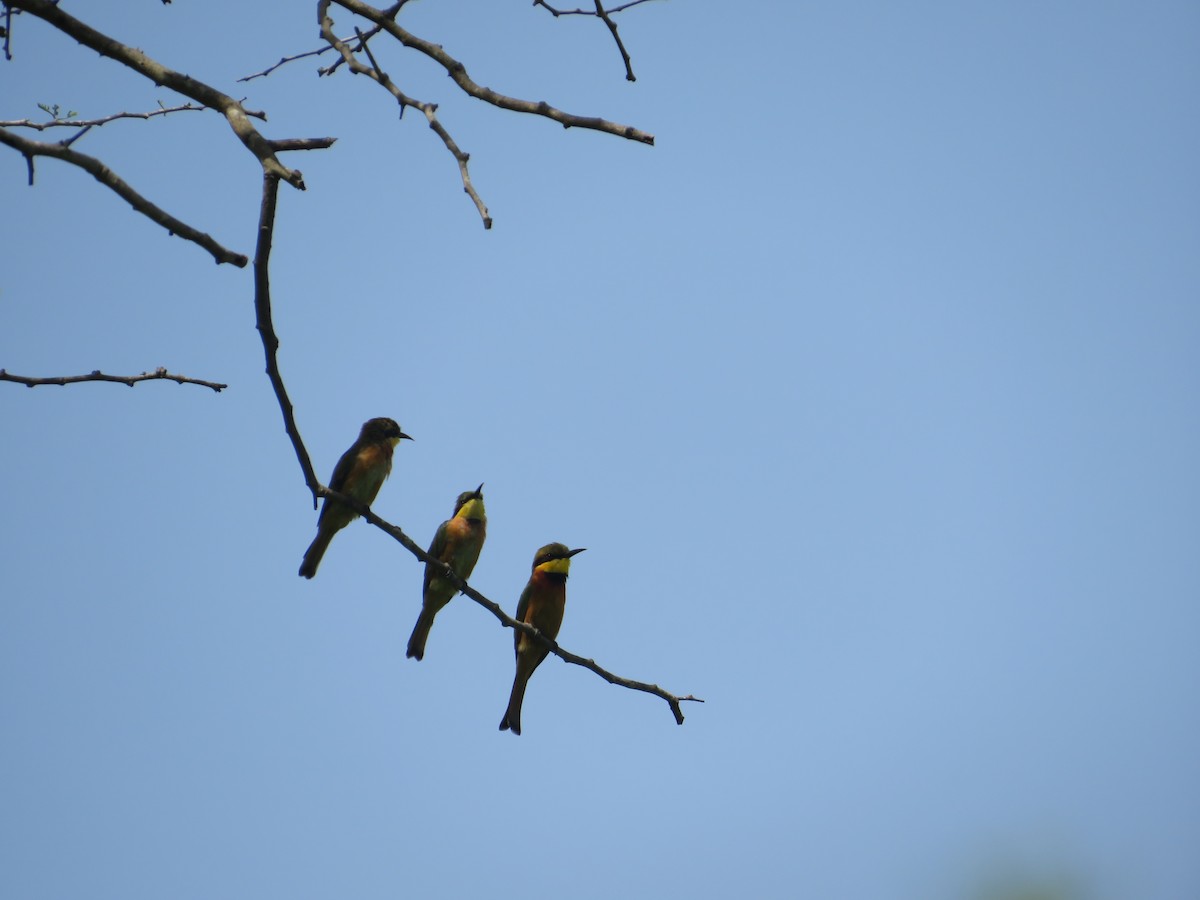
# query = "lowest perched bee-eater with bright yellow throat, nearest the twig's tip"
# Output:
<box><xmin>500</xmin><ymin>544</ymin><xmax>587</xmax><ymax>734</ymax></box>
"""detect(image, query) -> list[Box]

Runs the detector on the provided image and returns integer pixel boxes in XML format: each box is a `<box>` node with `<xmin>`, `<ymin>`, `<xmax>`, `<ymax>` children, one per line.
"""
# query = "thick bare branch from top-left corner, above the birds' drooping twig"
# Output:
<box><xmin>7</xmin><ymin>0</ymin><xmax>304</xmax><ymax>191</ymax></box>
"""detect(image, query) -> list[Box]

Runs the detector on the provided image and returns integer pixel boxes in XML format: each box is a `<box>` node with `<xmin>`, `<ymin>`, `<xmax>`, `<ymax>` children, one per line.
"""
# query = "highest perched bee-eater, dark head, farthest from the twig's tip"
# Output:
<box><xmin>300</xmin><ymin>419</ymin><xmax>412</xmax><ymax>578</ymax></box>
